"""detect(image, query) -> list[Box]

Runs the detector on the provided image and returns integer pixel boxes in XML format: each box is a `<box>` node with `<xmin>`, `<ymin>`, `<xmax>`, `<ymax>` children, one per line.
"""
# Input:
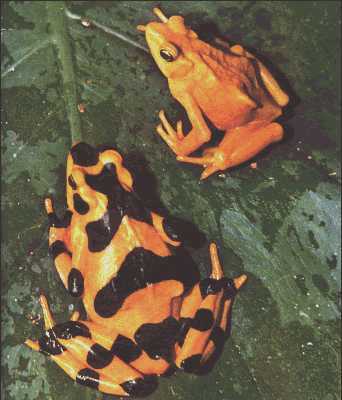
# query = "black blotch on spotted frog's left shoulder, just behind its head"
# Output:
<box><xmin>86</xmin><ymin>210</ymin><xmax>122</xmax><ymax>252</ymax></box>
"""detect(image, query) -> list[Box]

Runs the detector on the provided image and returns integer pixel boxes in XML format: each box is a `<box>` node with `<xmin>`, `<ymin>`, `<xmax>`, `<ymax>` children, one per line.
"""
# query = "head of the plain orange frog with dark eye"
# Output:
<box><xmin>137</xmin><ymin>8</ymin><xmax>197</xmax><ymax>79</ymax></box>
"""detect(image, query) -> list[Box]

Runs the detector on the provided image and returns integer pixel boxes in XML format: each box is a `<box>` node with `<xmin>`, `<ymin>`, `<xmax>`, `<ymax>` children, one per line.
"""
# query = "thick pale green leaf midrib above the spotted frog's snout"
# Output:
<box><xmin>46</xmin><ymin>1</ymin><xmax>82</xmax><ymax>144</ymax></box>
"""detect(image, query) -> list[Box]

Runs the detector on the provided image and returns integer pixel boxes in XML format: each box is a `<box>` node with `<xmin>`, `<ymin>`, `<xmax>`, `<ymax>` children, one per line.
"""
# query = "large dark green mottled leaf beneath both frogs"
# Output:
<box><xmin>2</xmin><ymin>1</ymin><xmax>341</xmax><ymax>400</ymax></box>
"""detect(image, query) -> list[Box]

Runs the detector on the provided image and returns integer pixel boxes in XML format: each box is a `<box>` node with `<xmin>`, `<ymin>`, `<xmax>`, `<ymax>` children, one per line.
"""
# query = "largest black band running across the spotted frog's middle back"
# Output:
<box><xmin>94</xmin><ymin>247</ymin><xmax>196</xmax><ymax>318</ymax></box>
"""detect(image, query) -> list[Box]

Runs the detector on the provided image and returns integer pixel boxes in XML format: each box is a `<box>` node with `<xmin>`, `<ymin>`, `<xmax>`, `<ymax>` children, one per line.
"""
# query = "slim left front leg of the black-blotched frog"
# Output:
<box><xmin>45</xmin><ymin>198</ymin><xmax>84</xmax><ymax>297</ymax></box>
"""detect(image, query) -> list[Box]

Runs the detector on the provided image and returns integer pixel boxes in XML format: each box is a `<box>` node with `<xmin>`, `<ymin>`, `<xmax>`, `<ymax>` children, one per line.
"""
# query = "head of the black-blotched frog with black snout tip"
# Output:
<box><xmin>67</xmin><ymin>142</ymin><xmax>133</xmax><ymax>214</ymax></box>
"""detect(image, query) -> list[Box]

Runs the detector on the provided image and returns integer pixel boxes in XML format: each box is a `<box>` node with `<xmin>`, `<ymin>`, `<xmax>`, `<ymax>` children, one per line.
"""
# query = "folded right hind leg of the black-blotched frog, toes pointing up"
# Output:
<box><xmin>175</xmin><ymin>243</ymin><xmax>247</xmax><ymax>373</ymax></box>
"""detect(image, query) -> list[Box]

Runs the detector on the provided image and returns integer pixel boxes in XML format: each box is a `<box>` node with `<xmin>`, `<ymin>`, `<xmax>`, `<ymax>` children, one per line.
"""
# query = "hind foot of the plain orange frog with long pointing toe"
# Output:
<box><xmin>177</xmin><ymin>147</ymin><xmax>229</xmax><ymax>180</ymax></box>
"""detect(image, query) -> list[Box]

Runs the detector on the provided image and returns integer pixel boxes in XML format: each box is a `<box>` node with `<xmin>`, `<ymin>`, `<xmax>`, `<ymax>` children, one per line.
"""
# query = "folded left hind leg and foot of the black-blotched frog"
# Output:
<box><xmin>25</xmin><ymin>296</ymin><xmax>157</xmax><ymax>397</ymax></box>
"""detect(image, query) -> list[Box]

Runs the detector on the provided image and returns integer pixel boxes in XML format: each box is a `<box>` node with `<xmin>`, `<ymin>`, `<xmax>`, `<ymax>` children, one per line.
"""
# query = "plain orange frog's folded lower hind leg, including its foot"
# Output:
<box><xmin>177</xmin><ymin>121</ymin><xmax>283</xmax><ymax>179</ymax></box>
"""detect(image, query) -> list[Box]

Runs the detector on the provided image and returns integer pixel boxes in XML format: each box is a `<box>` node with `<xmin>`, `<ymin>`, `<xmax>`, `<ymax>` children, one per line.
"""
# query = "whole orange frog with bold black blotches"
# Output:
<box><xmin>25</xmin><ymin>143</ymin><xmax>246</xmax><ymax>397</ymax></box>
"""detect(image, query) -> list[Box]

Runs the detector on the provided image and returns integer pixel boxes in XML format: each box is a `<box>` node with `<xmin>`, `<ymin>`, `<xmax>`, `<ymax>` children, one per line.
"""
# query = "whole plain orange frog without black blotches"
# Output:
<box><xmin>138</xmin><ymin>8</ymin><xmax>289</xmax><ymax>179</ymax></box>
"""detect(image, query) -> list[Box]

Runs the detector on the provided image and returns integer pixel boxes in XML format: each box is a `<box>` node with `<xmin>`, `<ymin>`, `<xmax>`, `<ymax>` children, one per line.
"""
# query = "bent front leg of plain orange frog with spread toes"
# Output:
<box><xmin>157</xmin><ymin>93</ymin><xmax>211</xmax><ymax>156</ymax></box>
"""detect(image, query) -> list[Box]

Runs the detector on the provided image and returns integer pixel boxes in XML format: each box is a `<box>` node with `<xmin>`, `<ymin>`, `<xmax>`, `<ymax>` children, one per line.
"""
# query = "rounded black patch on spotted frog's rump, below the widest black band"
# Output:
<box><xmin>134</xmin><ymin>317</ymin><xmax>180</xmax><ymax>362</ymax></box>
